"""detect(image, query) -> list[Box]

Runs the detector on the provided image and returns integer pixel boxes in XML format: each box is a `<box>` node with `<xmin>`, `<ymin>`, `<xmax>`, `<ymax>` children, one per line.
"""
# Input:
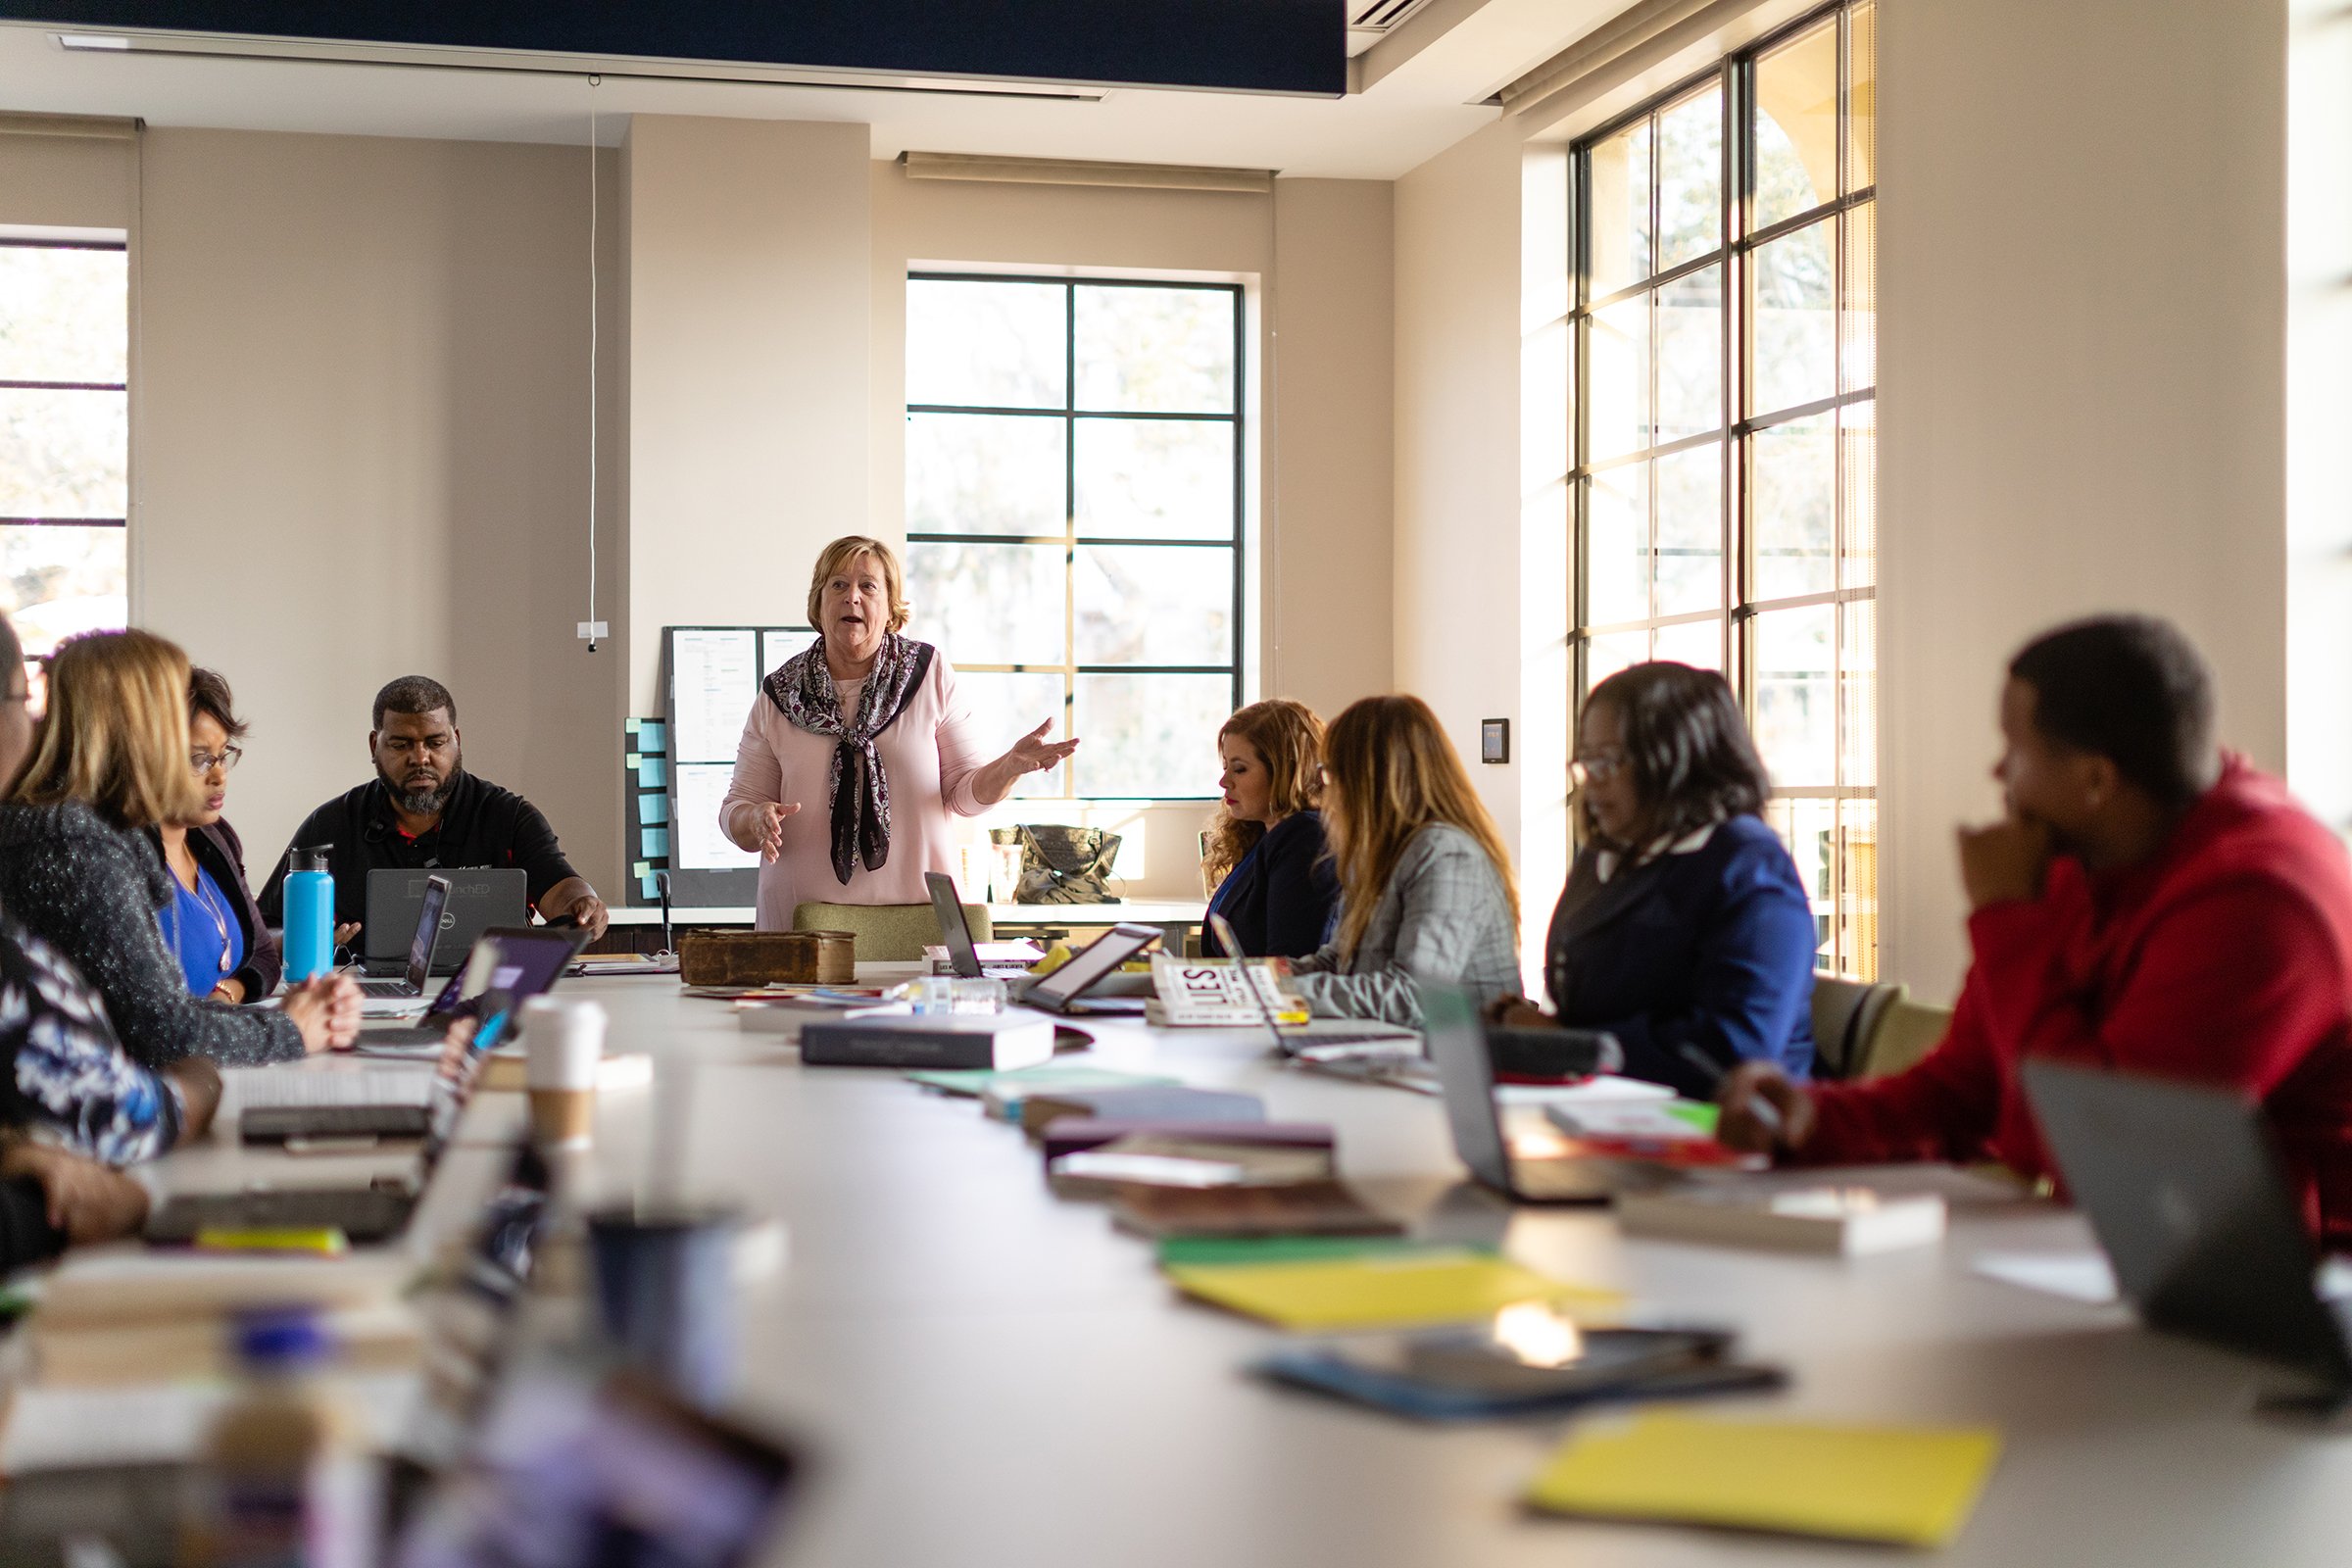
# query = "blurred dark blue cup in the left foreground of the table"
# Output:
<box><xmin>588</xmin><ymin>1206</ymin><xmax>741</xmax><ymax>1405</ymax></box>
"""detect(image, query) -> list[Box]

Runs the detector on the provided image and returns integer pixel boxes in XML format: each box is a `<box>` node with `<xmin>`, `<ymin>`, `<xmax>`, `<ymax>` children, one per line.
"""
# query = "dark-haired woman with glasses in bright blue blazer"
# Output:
<box><xmin>1498</xmin><ymin>662</ymin><xmax>1818</xmax><ymax>1101</ymax></box>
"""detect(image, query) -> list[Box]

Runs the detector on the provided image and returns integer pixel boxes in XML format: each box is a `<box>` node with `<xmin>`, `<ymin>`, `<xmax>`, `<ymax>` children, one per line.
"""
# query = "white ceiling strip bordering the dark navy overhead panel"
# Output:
<box><xmin>0</xmin><ymin>0</ymin><xmax>1625</xmax><ymax>178</ymax></box>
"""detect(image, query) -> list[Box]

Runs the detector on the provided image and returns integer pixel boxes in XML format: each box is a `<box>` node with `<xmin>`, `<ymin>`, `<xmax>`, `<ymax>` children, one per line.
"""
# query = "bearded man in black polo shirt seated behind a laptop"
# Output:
<box><xmin>261</xmin><ymin>674</ymin><xmax>610</xmax><ymax>943</ymax></box>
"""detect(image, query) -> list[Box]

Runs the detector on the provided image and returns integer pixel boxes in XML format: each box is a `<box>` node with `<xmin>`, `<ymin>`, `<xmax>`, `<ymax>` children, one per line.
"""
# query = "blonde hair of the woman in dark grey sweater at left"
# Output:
<box><xmin>10</xmin><ymin>632</ymin><xmax>205</xmax><ymax>827</ymax></box>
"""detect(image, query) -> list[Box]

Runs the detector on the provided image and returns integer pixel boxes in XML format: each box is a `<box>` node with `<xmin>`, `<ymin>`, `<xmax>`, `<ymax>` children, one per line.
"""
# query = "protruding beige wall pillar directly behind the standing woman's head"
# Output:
<box><xmin>623</xmin><ymin>116</ymin><xmax>870</xmax><ymax>714</ymax></box>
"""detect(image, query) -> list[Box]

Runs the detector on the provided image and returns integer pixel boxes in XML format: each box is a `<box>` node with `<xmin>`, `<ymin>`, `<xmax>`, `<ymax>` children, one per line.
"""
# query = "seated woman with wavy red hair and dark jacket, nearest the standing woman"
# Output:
<box><xmin>1200</xmin><ymin>698</ymin><xmax>1339</xmax><ymax>959</ymax></box>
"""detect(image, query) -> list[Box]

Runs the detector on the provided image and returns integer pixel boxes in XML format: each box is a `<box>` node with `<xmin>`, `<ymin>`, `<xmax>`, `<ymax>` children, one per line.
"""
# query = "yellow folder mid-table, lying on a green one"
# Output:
<box><xmin>1166</xmin><ymin>1249</ymin><xmax>1625</xmax><ymax>1333</ymax></box>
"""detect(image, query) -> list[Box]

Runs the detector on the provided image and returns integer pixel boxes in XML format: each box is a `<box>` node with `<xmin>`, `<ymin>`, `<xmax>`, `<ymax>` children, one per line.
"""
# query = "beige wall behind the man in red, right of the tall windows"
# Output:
<box><xmin>1880</xmin><ymin>0</ymin><xmax>2285</xmax><ymax>997</ymax></box>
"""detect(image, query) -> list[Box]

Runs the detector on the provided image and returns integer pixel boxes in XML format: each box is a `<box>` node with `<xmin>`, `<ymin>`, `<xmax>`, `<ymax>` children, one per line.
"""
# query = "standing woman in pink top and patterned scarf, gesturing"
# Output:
<box><xmin>719</xmin><ymin>536</ymin><xmax>1077</xmax><ymax>931</ymax></box>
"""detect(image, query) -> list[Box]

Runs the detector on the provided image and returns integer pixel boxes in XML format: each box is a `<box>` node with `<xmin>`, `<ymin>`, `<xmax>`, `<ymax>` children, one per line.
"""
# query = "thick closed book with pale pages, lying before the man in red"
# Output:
<box><xmin>1616</xmin><ymin>1183</ymin><xmax>1945</xmax><ymax>1257</ymax></box>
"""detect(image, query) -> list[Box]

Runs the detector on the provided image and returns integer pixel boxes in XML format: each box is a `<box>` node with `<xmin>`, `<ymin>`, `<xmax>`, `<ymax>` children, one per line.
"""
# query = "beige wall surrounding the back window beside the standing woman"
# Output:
<box><xmin>870</xmin><ymin>163</ymin><xmax>1393</xmax><ymax>898</ymax></box>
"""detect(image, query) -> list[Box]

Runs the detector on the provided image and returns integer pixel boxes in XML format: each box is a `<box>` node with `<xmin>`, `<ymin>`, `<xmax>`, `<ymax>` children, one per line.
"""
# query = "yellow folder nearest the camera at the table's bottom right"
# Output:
<box><xmin>1527</xmin><ymin>1410</ymin><xmax>2001</xmax><ymax>1546</ymax></box>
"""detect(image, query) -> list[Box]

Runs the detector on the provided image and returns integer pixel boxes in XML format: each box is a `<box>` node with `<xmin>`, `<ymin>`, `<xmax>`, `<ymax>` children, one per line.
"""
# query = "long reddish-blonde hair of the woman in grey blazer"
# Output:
<box><xmin>1324</xmin><ymin>696</ymin><xmax>1519</xmax><ymax>959</ymax></box>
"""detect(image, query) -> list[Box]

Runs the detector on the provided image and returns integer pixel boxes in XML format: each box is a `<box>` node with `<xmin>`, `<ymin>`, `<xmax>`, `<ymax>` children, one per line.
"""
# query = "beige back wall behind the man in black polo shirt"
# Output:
<box><xmin>0</xmin><ymin>129</ymin><xmax>618</xmax><ymax>889</ymax></box>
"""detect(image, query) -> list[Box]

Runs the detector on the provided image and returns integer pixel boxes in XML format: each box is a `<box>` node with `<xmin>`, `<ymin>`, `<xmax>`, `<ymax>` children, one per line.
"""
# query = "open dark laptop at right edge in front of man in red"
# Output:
<box><xmin>2023</xmin><ymin>1060</ymin><xmax>2352</xmax><ymax>1401</ymax></box>
